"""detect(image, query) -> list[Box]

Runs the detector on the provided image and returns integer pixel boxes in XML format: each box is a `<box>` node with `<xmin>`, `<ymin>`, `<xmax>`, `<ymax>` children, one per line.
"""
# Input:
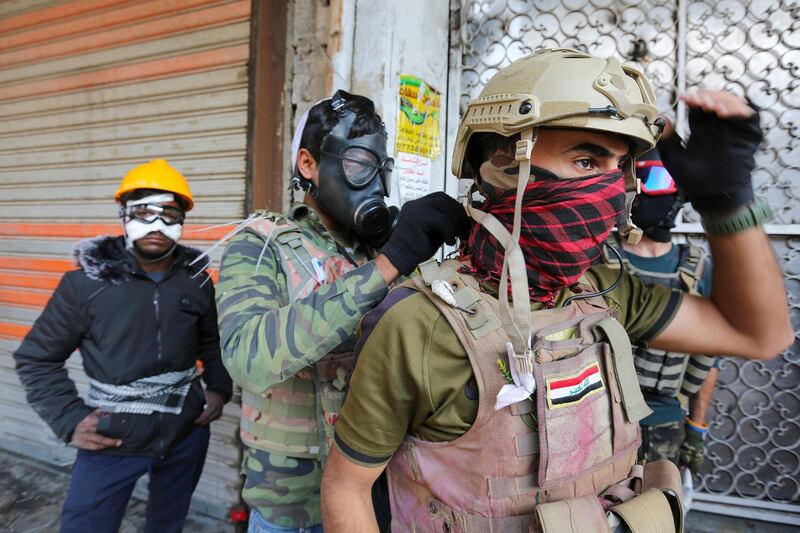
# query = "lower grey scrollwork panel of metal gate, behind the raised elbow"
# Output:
<box><xmin>699</xmin><ymin>239</ymin><xmax>800</xmax><ymax>503</ymax></box>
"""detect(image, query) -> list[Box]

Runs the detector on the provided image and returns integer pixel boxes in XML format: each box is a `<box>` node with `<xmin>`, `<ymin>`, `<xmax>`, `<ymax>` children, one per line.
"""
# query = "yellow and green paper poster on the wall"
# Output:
<box><xmin>395</xmin><ymin>74</ymin><xmax>442</xmax><ymax>159</ymax></box>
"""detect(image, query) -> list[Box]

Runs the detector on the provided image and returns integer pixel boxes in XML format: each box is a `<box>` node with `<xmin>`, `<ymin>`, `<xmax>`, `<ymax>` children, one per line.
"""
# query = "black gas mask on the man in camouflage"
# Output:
<box><xmin>309</xmin><ymin>91</ymin><xmax>399</xmax><ymax>248</ymax></box>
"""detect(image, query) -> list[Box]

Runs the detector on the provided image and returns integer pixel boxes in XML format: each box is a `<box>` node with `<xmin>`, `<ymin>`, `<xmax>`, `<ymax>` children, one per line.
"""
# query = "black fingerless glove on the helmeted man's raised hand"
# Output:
<box><xmin>658</xmin><ymin>104</ymin><xmax>763</xmax><ymax>213</ymax></box>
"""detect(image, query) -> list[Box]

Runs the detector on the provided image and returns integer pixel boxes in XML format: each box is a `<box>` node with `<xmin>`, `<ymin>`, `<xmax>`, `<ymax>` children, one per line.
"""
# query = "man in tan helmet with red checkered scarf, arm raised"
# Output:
<box><xmin>322</xmin><ymin>50</ymin><xmax>793</xmax><ymax>533</ymax></box>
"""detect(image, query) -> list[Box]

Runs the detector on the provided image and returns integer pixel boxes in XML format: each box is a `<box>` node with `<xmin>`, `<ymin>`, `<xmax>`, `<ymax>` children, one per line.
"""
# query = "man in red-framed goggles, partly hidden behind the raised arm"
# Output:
<box><xmin>603</xmin><ymin>150</ymin><xmax>719</xmax><ymax>478</ymax></box>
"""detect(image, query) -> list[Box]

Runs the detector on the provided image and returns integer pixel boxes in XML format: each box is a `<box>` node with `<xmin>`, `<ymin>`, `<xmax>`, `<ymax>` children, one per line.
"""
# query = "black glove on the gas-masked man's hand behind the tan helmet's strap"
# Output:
<box><xmin>380</xmin><ymin>192</ymin><xmax>469</xmax><ymax>276</ymax></box>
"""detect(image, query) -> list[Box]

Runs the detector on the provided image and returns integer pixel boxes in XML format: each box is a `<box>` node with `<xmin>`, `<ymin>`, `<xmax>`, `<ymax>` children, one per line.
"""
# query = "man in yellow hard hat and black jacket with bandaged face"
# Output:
<box><xmin>14</xmin><ymin>160</ymin><xmax>233</xmax><ymax>533</ymax></box>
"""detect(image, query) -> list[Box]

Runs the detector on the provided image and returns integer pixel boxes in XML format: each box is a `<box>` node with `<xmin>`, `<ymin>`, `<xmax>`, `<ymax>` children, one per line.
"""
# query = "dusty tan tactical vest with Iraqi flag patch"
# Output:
<box><xmin>387</xmin><ymin>261</ymin><xmax>682</xmax><ymax>533</ymax></box>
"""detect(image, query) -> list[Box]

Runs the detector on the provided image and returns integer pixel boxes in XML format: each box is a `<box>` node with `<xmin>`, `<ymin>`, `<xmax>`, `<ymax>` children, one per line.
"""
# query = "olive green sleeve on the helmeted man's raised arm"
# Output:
<box><xmin>588</xmin><ymin>265</ymin><xmax>683</xmax><ymax>342</ymax></box>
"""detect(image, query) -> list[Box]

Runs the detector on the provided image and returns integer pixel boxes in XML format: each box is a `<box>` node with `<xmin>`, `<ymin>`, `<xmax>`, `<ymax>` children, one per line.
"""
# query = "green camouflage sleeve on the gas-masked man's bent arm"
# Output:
<box><xmin>212</xmin><ymin>231</ymin><xmax>388</xmax><ymax>393</ymax></box>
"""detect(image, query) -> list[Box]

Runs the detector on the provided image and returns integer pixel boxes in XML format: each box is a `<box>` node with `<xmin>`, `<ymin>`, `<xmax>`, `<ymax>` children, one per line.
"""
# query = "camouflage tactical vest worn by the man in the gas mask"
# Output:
<box><xmin>240</xmin><ymin>215</ymin><xmax>355</xmax><ymax>461</ymax></box>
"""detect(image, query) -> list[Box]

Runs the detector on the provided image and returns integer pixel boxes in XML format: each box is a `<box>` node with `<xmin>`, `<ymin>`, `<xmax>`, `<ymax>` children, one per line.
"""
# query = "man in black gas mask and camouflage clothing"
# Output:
<box><xmin>218</xmin><ymin>91</ymin><xmax>468</xmax><ymax>531</ymax></box>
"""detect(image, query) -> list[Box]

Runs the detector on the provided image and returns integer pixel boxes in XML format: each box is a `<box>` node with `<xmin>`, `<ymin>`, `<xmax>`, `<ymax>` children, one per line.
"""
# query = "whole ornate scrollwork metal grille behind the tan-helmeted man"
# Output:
<box><xmin>456</xmin><ymin>0</ymin><xmax>800</xmax><ymax>512</ymax></box>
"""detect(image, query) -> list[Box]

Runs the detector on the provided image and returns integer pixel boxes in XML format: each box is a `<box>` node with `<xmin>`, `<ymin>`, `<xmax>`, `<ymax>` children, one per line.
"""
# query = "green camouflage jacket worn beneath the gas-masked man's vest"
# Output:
<box><xmin>212</xmin><ymin>204</ymin><xmax>388</xmax><ymax>528</ymax></box>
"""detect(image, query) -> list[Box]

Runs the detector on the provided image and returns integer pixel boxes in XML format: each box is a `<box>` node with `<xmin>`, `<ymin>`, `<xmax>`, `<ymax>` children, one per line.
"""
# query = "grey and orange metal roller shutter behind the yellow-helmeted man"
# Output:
<box><xmin>0</xmin><ymin>0</ymin><xmax>252</xmax><ymax>514</ymax></box>
